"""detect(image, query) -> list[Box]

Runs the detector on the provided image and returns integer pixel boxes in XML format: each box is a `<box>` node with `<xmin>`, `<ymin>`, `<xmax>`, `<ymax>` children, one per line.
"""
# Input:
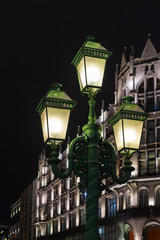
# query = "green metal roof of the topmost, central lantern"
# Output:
<box><xmin>71</xmin><ymin>35</ymin><xmax>112</xmax><ymax>67</ymax></box>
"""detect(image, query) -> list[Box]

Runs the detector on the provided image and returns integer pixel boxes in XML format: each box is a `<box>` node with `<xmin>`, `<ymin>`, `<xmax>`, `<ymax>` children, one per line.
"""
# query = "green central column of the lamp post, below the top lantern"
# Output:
<box><xmin>83</xmin><ymin>99</ymin><xmax>101</xmax><ymax>240</ymax></box>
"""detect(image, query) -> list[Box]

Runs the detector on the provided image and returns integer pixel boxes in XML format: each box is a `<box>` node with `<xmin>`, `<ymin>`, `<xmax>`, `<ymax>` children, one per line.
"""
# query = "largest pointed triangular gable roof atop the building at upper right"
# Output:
<box><xmin>141</xmin><ymin>38</ymin><xmax>159</xmax><ymax>59</ymax></box>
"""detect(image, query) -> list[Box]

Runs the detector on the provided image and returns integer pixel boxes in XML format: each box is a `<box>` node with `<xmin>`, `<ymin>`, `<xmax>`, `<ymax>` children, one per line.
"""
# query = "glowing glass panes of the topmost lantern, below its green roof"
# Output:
<box><xmin>77</xmin><ymin>56</ymin><xmax>106</xmax><ymax>91</ymax></box>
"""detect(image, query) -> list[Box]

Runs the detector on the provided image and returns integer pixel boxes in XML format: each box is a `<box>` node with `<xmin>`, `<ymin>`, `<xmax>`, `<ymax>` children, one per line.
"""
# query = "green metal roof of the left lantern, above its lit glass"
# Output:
<box><xmin>36</xmin><ymin>83</ymin><xmax>76</xmax><ymax>115</ymax></box>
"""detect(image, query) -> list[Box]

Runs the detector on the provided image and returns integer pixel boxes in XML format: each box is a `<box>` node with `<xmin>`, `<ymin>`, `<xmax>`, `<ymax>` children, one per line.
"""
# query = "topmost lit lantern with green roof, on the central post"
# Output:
<box><xmin>72</xmin><ymin>36</ymin><xmax>111</xmax><ymax>93</ymax></box>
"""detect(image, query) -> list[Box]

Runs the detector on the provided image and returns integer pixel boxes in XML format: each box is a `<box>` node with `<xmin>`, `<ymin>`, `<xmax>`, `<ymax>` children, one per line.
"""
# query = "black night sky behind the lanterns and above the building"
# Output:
<box><xmin>0</xmin><ymin>0</ymin><xmax>160</xmax><ymax>224</ymax></box>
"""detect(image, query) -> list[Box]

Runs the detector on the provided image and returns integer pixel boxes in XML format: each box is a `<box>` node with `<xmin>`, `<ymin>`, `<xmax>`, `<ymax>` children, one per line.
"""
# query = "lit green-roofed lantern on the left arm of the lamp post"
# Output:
<box><xmin>36</xmin><ymin>83</ymin><xmax>76</xmax><ymax>143</ymax></box>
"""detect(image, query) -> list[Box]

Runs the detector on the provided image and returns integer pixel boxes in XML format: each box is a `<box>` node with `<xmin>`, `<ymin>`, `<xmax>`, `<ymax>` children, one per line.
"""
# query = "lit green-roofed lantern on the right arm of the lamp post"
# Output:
<box><xmin>108</xmin><ymin>96</ymin><xmax>147</xmax><ymax>152</ymax></box>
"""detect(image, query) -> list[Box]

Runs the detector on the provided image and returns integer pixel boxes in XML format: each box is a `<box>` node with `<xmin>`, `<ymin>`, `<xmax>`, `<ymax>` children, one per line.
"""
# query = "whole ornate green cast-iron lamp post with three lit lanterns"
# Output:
<box><xmin>37</xmin><ymin>37</ymin><xmax>146</xmax><ymax>240</ymax></box>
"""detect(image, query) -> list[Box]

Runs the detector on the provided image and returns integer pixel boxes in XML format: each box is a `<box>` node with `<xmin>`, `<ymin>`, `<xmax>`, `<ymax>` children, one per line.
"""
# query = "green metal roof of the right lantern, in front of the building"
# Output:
<box><xmin>108</xmin><ymin>96</ymin><xmax>148</xmax><ymax>126</ymax></box>
